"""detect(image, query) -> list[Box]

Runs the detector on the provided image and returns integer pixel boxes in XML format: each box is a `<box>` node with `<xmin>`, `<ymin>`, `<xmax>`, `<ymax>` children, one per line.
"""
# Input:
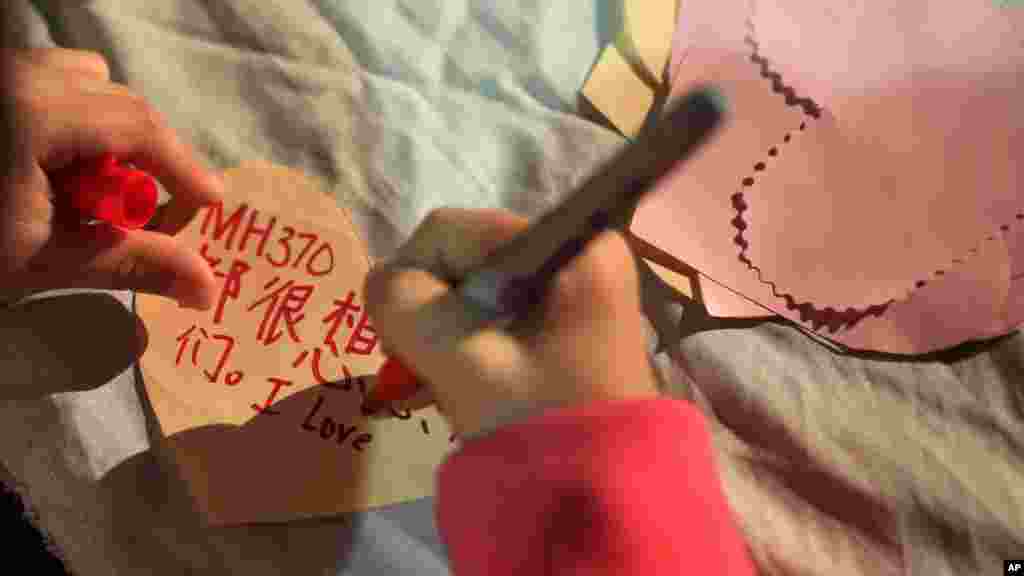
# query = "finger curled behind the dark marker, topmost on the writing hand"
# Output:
<box><xmin>395</xmin><ymin>208</ymin><xmax>528</xmax><ymax>279</ymax></box>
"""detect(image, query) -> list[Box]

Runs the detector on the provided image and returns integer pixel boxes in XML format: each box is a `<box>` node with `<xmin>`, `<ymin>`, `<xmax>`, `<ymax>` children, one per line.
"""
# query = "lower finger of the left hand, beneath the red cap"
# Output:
<box><xmin>26</xmin><ymin>224</ymin><xmax>217</xmax><ymax>310</ymax></box>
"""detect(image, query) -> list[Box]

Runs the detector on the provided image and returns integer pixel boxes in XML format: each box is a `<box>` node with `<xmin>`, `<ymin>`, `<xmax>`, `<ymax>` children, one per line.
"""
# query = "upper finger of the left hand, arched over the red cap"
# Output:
<box><xmin>33</xmin><ymin>85</ymin><xmax>223</xmax><ymax>234</ymax></box>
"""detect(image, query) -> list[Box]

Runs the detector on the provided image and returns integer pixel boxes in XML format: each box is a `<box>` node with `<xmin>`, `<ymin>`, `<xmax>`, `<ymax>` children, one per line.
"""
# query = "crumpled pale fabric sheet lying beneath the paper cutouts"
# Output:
<box><xmin>0</xmin><ymin>0</ymin><xmax>1024</xmax><ymax>576</ymax></box>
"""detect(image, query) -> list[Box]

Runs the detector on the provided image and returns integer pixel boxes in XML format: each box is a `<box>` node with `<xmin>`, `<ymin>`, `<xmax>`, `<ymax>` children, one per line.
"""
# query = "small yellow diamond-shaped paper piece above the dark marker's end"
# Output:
<box><xmin>583</xmin><ymin>44</ymin><xmax>654</xmax><ymax>138</ymax></box>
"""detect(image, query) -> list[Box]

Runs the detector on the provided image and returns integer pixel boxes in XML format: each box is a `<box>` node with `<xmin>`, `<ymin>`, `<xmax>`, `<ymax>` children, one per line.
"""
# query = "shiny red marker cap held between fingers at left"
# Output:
<box><xmin>63</xmin><ymin>154</ymin><xmax>157</xmax><ymax>229</ymax></box>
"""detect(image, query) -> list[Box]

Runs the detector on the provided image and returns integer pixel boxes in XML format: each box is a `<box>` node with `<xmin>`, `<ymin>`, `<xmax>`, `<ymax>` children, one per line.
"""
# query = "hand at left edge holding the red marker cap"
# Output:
<box><xmin>0</xmin><ymin>49</ymin><xmax>223</xmax><ymax>310</ymax></box>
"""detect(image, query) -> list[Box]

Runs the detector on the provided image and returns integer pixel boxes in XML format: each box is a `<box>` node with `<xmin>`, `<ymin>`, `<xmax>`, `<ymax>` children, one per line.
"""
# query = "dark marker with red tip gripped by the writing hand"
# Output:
<box><xmin>368</xmin><ymin>87</ymin><xmax>726</xmax><ymax>406</ymax></box>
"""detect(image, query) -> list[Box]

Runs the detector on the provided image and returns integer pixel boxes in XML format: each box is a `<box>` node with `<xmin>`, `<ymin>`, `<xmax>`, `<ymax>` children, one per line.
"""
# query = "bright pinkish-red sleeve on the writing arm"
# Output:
<box><xmin>437</xmin><ymin>399</ymin><xmax>755</xmax><ymax>576</ymax></box>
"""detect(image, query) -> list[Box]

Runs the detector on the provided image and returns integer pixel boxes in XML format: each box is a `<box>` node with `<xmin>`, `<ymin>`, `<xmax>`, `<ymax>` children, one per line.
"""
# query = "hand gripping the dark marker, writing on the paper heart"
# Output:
<box><xmin>364</xmin><ymin>209</ymin><xmax>657</xmax><ymax>437</ymax></box>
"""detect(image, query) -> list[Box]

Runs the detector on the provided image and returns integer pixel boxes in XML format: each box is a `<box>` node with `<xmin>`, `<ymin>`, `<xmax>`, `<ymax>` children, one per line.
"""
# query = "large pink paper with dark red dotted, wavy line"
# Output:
<box><xmin>632</xmin><ymin>0</ymin><xmax>1024</xmax><ymax>354</ymax></box>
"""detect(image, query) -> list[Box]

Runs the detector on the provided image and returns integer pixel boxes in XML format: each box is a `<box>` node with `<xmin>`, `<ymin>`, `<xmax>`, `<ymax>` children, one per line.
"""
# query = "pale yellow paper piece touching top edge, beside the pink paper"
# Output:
<box><xmin>616</xmin><ymin>0</ymin><xmax>676</xmax><ymax>85</ymax></box>
